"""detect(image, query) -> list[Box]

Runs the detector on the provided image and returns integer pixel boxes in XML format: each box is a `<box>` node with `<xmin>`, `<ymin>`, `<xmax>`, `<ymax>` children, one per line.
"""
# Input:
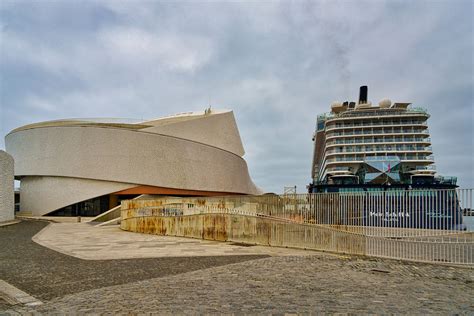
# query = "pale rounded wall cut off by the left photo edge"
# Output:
<box><xmin>0</xmin><ymin>150</ymin><xmax>15</xmax><ymax>222</ymax></box>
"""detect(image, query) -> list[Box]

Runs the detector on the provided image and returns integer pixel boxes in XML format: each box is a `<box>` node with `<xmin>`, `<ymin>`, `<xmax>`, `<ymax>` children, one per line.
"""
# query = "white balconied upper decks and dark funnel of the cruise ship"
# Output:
<box><xmin>309</xmin><ymin>86</ymin><xmax>456</xmax><ymax>192</ymax></box>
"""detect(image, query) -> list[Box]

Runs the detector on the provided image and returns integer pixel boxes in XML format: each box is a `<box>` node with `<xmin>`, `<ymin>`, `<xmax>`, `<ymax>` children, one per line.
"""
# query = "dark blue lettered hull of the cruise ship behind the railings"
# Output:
<box><xmin>309</xmin><ymin>185</ymin><xmax>466</xmax><ymax>230</ymax></box>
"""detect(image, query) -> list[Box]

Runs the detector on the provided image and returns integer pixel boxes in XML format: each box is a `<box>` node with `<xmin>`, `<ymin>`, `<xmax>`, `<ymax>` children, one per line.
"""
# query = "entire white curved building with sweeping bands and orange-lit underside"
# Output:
<box><xmin>5</xmin><ymin>110</ymin><xmax>261</xmax><ymax>216</ymax></box>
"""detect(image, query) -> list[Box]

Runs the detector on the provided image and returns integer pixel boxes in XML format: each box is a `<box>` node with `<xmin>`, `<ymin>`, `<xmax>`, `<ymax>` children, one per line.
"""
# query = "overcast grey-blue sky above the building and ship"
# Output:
<box><xmin>0</xmin><ymin>0</ymin><xmax>474</xmax><ymax>192</ymax></box>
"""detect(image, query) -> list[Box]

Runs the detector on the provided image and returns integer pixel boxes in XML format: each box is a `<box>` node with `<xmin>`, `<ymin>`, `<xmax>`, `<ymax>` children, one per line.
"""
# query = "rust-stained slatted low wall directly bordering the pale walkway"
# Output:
<box><xmin>120</xmin><ymin>214</ymin><xmax>366</xmax><ymax>255</ymax></box>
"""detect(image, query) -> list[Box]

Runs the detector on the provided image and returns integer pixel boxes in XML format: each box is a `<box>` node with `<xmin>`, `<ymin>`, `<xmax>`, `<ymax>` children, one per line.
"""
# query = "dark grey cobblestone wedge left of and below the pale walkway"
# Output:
<box><xmin>0</xmin><ymin>221</ymin><xmax>265</xmax><ymax>304</ymax></box>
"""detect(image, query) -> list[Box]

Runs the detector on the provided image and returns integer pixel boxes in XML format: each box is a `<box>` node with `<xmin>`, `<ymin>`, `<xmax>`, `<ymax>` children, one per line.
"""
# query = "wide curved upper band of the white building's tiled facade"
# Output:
<box><xmin>6</xmin><ymin>127</ymin><xmax>259</xmax><ymax>194</ymax></box>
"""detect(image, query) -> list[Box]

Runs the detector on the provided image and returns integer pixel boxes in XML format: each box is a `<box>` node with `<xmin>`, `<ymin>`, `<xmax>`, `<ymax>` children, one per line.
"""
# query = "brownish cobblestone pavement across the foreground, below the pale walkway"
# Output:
<box><xmin>0</xmin><ymin>220</ymin><xmax>474</xmax><ymax>315</ymax></box>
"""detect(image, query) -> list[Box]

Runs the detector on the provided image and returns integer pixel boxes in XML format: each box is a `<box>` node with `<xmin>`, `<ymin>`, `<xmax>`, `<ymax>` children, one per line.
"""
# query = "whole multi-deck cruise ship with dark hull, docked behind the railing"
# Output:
<box><xmin>308</xmin><ymin>86</ymin><xmax>465</xmax><ymax>230</ymax></box>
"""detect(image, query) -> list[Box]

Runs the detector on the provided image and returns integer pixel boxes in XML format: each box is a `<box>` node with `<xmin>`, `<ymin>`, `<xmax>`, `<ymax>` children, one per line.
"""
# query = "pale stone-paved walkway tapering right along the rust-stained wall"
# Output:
<box><xmin>33</xmin><ymin>223</ymin><xmax>314</xmax><ymax>260</ymax></box>
